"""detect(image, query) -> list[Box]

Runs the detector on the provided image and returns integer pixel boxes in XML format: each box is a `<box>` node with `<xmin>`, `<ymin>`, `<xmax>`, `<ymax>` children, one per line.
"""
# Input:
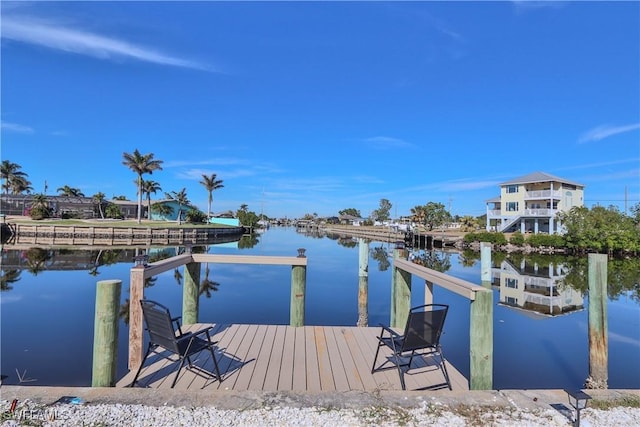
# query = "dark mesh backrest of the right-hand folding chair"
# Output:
<box><xmin>402</xmin><ymin>304</ymin><xmax>449</xmax><ymax>351</ymax></box>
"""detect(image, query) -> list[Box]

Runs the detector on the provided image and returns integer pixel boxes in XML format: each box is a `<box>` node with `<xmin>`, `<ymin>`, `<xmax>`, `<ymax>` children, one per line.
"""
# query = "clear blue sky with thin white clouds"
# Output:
<box><xmin>1</xmin><ymin>1</ymin><xmax>640</xmax><ymax>221</ymax></box>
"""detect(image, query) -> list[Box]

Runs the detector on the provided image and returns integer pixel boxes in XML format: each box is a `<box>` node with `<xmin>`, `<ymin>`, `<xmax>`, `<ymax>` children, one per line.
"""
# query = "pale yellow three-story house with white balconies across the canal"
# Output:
<box><xmin>486</xmin><ymin>172</ymin><xmax>584</xmax><ymax>234</ymax></box>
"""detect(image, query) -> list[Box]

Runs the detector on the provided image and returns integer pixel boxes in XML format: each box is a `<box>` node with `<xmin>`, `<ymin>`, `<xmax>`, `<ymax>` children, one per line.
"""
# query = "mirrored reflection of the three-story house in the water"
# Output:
<box><xmin>491</xmin><ymin>259</ymin><xmax>584</xmax><ymax>316</ymax></box>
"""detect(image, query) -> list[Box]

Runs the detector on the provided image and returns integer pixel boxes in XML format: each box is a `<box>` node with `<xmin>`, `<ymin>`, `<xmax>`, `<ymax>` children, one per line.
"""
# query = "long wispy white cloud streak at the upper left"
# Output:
<box><xmin>2</xmin><ymin>16</ymin><xmax>217</xmax><ymax>71</ymax></box>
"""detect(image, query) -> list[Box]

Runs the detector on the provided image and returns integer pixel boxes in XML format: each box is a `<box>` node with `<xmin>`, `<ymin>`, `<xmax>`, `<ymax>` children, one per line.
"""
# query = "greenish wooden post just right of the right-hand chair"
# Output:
<box><xmin>469</xmin><ymin>289</ymin><xmax>493</xmax><ymax>390</ymax></box>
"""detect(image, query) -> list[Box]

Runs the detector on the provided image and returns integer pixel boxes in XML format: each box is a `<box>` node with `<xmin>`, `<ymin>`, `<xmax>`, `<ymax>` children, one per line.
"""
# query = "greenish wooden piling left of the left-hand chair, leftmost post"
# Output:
<box><xmin>91</xmin><ymin>280</ymin><xmax>122</xmax><ymax>387</ymax></box>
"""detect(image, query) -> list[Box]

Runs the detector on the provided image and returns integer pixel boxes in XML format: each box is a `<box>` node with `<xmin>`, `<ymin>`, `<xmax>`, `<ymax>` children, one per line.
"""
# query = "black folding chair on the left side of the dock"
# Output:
<box><xmin>130</xmin><ymin>300</ymin><xmax>222</xmax><ymax>388</ymax></box>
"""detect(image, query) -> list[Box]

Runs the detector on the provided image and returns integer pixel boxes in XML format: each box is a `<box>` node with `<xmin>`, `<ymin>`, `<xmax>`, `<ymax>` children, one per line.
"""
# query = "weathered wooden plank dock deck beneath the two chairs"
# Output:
<box><xmin>116</xmin><ymin>323</ymin><xmax>469</xmax><ymax>393</ymax></box>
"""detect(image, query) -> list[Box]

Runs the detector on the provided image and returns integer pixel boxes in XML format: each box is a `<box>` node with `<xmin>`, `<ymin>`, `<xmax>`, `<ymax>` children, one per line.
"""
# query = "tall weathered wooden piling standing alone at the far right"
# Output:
<box><xmin>586</xmin><ymin>254</ymin><xmax>609</xmax><ymax>388</ymax></box>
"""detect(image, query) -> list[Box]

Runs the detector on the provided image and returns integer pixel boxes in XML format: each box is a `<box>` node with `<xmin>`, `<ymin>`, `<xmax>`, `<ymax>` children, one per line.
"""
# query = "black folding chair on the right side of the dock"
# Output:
<box><xmin>371</xmin><ymin>304</ymin><xmax>451</xmax><ymax>390</ymax></box>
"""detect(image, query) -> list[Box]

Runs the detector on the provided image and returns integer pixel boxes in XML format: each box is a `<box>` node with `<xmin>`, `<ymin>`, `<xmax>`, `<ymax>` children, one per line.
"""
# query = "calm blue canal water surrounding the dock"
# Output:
<box><xmin>0</xmin><ymin>228</ymin><xmax>640</xmax><ymax>389</ymax></box>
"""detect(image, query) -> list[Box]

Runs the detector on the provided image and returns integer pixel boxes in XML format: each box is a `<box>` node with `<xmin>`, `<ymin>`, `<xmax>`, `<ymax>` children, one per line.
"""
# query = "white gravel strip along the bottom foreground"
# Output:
<box><xmin>0</xmin><ymin>400</ymin><xmax>640</xmax><ymax>427</ymax></box>
